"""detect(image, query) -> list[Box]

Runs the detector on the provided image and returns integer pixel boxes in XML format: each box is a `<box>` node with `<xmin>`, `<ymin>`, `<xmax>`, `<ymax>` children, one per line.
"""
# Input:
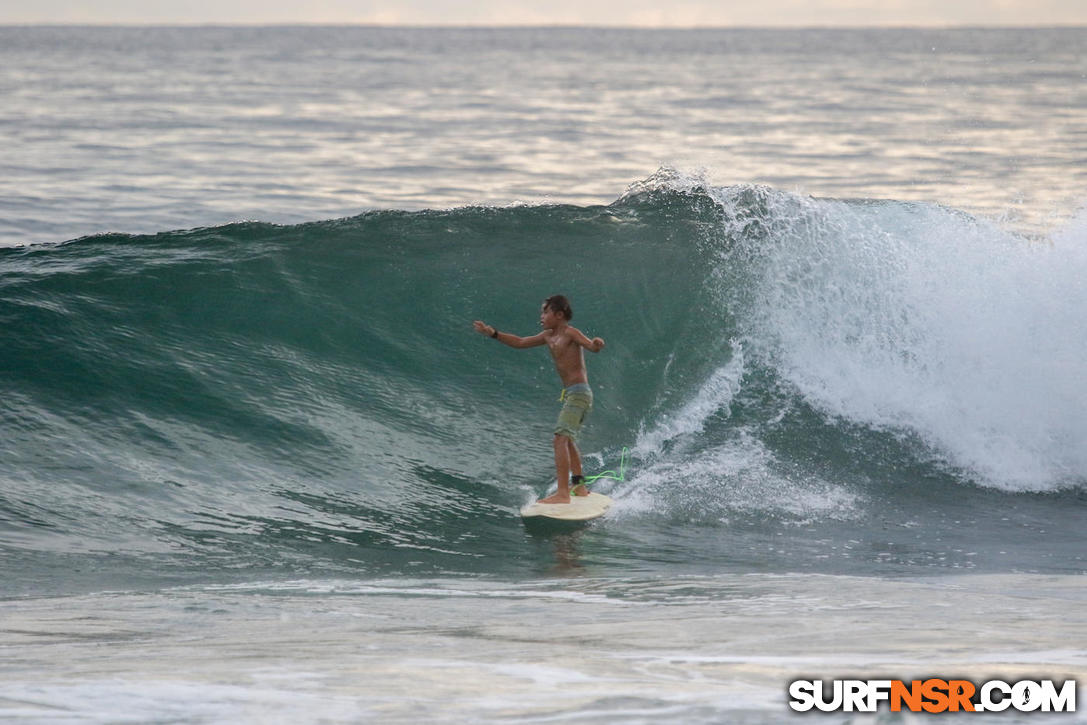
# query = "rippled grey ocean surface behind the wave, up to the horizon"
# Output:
<box><xmin>0</xmin><ymin>27</ymin><xmax>1087</xmax><ymax>245</ymax></box>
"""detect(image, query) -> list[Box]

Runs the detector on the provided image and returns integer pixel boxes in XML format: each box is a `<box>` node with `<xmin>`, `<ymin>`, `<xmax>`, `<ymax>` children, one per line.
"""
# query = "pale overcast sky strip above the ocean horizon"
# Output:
<box><xmin>6</xmin><ymin>0</ymin><xmax>1087</xmax><ymax>27</ymax></box>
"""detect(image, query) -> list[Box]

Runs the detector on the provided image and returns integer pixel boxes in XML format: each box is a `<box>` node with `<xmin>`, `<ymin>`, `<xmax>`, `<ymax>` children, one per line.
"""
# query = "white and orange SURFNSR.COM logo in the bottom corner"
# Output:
<box><xmin>789</xmin><ymin>677</ymin><xmax>1076</xmax><ymax>713</ymax></box>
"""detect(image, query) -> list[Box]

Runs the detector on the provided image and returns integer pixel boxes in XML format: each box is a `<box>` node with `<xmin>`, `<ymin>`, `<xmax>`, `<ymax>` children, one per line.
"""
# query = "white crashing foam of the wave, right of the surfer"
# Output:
<box><xmin>628</xmin><ymin>170</ymin><xmax>1087</xmax><ymax>491</ymax></box>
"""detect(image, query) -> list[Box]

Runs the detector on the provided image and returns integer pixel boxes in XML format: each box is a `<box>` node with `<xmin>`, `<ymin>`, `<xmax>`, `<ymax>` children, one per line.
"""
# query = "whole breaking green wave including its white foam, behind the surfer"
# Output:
<box><xmin>0</xmin><ymin>170</ymin><xmax>1087</xmax><ymax>589</ymax></box>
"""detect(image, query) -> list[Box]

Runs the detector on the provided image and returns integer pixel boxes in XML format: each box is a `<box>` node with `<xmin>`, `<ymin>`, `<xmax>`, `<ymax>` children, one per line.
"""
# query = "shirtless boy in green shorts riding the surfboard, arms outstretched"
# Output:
<box><xmin>473</xmin><ymin>295</ymin><xmax>604</xmax><ymax>503</ymax></box>
